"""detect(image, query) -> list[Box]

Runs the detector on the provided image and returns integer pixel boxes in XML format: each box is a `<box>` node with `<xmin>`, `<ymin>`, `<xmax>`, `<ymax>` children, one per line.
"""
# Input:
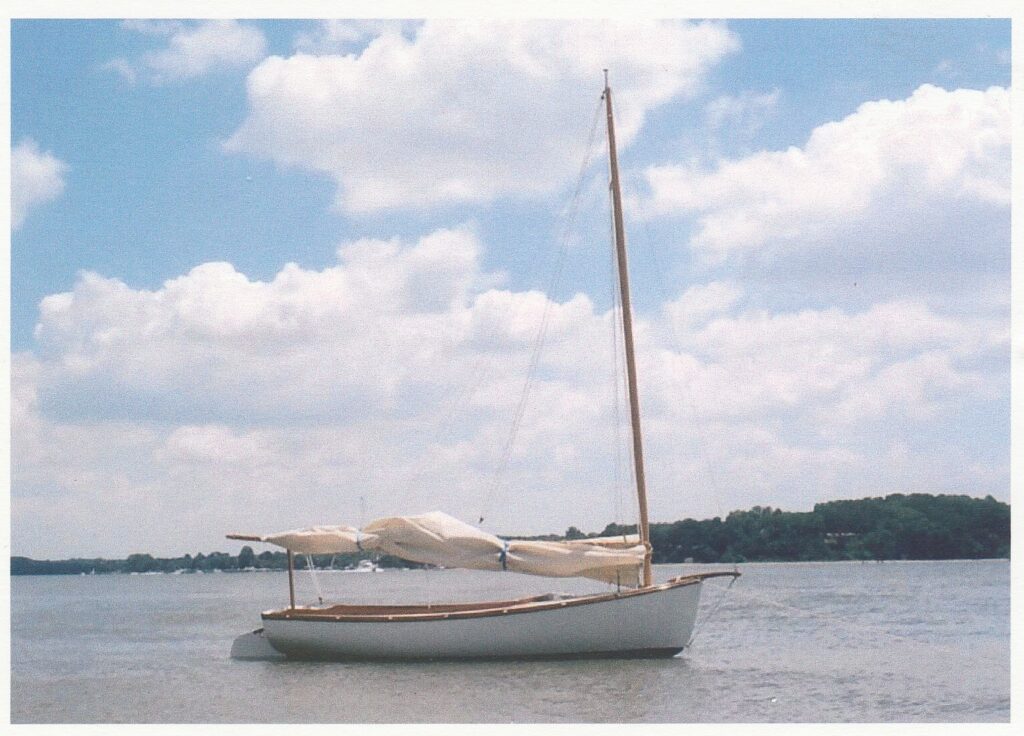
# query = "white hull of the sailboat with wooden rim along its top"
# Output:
<box><xmin>251</xmin><ymin>573</ymin><xmax>733</xmax><ymax>660</ymax></box>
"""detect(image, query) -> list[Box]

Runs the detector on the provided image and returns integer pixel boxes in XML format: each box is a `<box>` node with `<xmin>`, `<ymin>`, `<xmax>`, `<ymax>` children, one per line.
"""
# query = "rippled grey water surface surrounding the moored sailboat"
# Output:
<box><xmin>11</xmin><ymin>560</ymin><xmax>1010</xmax><ymax>723</ymax></box>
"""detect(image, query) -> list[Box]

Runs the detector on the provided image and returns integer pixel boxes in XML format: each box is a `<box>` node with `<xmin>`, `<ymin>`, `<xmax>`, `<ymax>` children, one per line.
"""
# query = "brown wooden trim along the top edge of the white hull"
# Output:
<box><xmin>261</xmin><ymin>571</ymin><xmax>739</xmax><ymax>622</ymax></box>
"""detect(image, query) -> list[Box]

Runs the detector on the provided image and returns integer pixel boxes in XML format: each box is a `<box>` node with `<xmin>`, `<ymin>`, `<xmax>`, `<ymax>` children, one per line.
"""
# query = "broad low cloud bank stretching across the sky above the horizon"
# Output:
<box><xmin>12</xmin><ymin>227</ymin><xmax>1009</xmax><ymax>554</ymax></box>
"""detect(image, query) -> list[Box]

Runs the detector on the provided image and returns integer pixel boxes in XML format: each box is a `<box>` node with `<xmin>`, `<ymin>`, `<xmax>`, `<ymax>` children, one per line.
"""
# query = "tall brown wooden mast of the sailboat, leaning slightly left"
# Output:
<box><xmin>604</xmin><ymin>70</ymin><xmax>652</xmax><ymax>588</ymax></box>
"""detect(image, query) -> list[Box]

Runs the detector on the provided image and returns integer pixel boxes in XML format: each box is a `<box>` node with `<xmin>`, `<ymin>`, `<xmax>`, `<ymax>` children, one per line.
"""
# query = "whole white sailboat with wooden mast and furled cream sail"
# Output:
<box><xmin>227</xmin><ymin>74</ymin><xmax>739</xmax><ymax>659</ymax></box>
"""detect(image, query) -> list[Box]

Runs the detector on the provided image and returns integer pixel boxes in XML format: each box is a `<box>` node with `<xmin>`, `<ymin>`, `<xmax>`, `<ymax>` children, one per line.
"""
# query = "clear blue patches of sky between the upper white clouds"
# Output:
<box><xmin>11</xmin><ymin>19</ymin><xmax>1010</xmax><ymax>349</ymax></box>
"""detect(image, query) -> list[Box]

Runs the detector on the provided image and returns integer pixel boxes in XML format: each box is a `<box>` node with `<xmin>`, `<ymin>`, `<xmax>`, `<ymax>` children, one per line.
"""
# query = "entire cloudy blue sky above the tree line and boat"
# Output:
<box><xmin>11</xmin><ymin>19</ymin><xmax>1010</xmax><ymax>556</ymax></box>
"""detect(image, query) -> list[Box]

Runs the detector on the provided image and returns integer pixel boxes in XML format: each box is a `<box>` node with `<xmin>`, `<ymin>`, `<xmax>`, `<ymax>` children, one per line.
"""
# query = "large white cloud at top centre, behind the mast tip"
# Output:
<box><xmin>226</xmin><ymin>20</ymin><xmax>738</xmax><ymax>213</ymax></box>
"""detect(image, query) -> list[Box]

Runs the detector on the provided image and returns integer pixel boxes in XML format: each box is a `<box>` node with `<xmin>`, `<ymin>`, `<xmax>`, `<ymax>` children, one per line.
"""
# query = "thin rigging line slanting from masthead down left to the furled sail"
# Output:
<box><xmin>479</xmin><ymin>95</ymin><xmax>602</xmax><ymax>524</ymax></box>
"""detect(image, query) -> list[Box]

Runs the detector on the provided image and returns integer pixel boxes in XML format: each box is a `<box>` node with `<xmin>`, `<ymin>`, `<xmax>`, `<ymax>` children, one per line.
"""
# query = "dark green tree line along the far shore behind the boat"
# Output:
<box><xmin>10</xmin><ymin>493</ymin><xmax>1010</xmax><ymax>575</ymax></box>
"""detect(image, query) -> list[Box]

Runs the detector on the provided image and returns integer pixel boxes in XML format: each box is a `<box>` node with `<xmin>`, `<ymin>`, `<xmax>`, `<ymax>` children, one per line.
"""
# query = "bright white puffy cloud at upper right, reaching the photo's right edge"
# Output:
<box><xmin>638</xmin><ymin>85</ymin><xmax>1011</xmax><ymax>260</ymax></box>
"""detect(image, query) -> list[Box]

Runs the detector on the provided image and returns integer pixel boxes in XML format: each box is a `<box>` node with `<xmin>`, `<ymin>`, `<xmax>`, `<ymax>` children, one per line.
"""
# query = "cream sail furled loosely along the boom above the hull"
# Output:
<box><xmin>260</xmin><ymin>511</ymin><xmax>644</xmax><ymax>586</ymax></box>
